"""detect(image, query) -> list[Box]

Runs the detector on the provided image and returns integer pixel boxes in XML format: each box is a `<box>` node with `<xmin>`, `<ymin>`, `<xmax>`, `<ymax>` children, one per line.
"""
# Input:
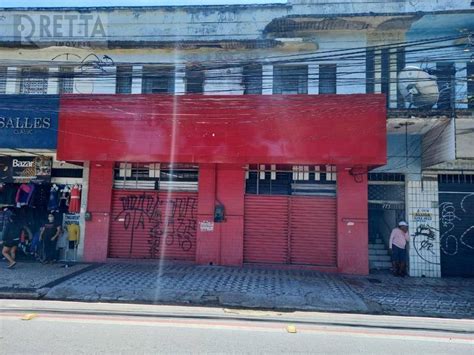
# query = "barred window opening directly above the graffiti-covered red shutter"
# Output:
<box><xmin>114</xmin><ymin>162</ymin><xmax>199</xmax><ymax>191</ymax></box>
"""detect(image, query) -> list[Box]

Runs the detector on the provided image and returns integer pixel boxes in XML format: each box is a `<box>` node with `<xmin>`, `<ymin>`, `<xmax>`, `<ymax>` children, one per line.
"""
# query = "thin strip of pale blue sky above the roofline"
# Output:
<box><xmin>0</xmin><ymin>0</ymin><xmax>287</xmax><ymax>7</ymax></box>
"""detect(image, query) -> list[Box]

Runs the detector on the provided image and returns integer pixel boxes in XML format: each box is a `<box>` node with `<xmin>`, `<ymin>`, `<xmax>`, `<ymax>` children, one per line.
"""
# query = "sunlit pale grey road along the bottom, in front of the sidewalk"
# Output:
<box><xmin>0</xmin><ymin>301</ymin><xmax>474</xmax><ymax>355</ymax></box>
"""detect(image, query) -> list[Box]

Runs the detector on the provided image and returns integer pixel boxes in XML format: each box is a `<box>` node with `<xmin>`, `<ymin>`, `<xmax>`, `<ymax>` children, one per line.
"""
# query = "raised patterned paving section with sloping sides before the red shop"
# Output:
<box><xmin>46</xmin><ymin>263</ymin><xmax>367</xmax><ymax>312</ymax></box>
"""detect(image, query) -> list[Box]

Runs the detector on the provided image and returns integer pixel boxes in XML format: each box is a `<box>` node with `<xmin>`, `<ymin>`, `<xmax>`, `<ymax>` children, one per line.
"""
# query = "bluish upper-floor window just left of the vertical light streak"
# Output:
<box><xmin>142</xmin><ymin>66</ymin><xmax>175</xmax><ymax>94</ymax></box>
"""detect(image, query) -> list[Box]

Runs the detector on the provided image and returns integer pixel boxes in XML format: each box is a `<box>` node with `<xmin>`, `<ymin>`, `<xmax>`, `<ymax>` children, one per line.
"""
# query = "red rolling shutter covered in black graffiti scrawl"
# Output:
<box><xmin>109</xmin><ymin>190</ymin><xmax>197</xmax><ymax>261</ymax></box>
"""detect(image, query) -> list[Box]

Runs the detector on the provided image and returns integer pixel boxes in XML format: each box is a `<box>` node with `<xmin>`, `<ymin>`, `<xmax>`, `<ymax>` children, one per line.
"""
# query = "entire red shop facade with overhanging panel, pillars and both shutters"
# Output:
<box><xmin>57</xmin><ymin>94</ymin><xmax>386</xmax><ymax>274</ymax></box>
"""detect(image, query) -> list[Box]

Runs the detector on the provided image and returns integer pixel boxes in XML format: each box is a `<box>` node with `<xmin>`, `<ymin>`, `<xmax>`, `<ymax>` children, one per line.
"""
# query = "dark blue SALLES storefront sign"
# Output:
<box><xmin>0</xmin><ymin>95</ymin><xmax>59</xmax><ymax>149</ymax></box>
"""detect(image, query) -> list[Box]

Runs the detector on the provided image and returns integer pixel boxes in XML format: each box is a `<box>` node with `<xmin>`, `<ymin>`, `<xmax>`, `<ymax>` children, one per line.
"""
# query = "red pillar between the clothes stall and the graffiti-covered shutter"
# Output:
<box><xmin>84</xmin><ymin>162</ymin><xmax>113</xmax><ymax>262</ymax></box>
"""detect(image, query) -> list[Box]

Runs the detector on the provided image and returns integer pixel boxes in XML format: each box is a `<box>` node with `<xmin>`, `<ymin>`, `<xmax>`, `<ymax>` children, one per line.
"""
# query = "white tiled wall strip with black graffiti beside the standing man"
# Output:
<box><xmin>406</xmin><ymin>181</ymin><xmax>441</xmax><ymax>277</ymax></box>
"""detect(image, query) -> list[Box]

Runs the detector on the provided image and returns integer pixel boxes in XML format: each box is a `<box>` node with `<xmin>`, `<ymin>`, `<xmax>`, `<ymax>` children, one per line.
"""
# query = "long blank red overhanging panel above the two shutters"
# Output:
<box><xmin>57</xmin><ymin>94</ymin><xmax>386</xmax><ymax>166</ymax></box>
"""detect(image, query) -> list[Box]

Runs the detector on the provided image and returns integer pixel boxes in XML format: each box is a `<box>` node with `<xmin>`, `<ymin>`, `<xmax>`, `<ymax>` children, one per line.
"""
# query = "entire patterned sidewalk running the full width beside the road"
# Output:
<box><xmin>0</xmin><ymin>262</ymin><xmax>474</xmax><ymax>318</ymax></box>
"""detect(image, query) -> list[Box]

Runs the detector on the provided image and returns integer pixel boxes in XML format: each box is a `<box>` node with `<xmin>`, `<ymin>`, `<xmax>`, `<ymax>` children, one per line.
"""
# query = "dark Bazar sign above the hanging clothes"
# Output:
<box><xmin>0</xmin><ymin>156</ymin><xmax>53</xmax><ymax>183</ymax></box>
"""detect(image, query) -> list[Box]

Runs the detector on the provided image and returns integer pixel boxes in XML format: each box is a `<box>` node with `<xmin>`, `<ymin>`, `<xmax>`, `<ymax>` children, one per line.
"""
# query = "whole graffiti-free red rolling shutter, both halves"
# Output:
<box><xmin>244</xmin><ymin>195</ymin><xmax>337</xmax><ymax>266</ymax></box>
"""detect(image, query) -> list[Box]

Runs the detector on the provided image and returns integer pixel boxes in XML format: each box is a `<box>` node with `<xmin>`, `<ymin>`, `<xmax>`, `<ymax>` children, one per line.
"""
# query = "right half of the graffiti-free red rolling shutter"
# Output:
<box><xmin>290</xmin><ymin>196</ymin><xmax>336</xmax><ymax>266</ymax></box>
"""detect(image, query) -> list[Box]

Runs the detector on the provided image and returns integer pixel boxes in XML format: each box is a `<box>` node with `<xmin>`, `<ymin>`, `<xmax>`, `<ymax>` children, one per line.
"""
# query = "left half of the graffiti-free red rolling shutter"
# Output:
<box><xmin>244</xmin><ymin>195</ymin><xmax>288</xmax><ymax>264</ymax></box>
